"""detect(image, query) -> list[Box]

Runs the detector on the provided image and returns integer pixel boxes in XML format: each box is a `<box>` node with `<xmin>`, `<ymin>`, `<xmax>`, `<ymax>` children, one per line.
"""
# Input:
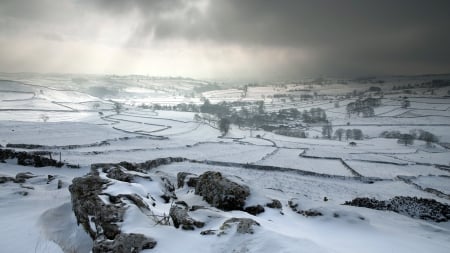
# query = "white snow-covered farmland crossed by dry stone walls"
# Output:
<box><xmin>0</xmin><ymin>76</ymin><xmax>450</xmax><ymax>253</ymax></box>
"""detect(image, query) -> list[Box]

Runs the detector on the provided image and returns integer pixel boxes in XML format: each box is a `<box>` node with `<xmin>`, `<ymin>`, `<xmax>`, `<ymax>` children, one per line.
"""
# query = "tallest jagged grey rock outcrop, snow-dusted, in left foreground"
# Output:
<box><xmin>69</xmin><ymin>168</ymin><xmax>156</xmax><ymax>253</ymax></box>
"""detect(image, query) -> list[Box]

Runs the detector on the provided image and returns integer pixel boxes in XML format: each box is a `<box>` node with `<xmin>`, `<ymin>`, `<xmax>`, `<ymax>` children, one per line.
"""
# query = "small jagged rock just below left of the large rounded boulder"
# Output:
<box><xmin>169</xmin><ymin>201</ymin><xmax>205</xmax><ymax>230</ymax></box>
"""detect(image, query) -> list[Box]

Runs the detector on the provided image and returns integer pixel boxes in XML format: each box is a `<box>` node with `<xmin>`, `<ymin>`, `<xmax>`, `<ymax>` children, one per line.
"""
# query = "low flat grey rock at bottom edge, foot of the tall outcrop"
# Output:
<box><xmin>92</xmin><ymin>233</ymin><xmax>156</xmax><ymax>253</ymax></box>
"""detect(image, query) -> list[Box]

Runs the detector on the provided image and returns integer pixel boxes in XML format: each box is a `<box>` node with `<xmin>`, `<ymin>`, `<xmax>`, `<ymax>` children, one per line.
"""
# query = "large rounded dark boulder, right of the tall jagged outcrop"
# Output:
<box><xmin>195</xmin><ymin>171</ymin><xmax>250</xmax><ymax>211</ymax></box>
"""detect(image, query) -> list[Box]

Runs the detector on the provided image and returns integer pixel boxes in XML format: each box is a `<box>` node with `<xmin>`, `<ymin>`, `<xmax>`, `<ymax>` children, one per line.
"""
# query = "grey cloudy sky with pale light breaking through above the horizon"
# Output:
<box><xmin>0</xmin><ymin>0</ymin><xmax>450</xmax><ymax>80</ymax></box>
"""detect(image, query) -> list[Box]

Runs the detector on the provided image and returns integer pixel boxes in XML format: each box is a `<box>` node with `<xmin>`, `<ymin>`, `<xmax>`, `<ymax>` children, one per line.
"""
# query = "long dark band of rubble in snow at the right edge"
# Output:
<box><xmin>344</xmin><ymin>196</ymin><xmax>450</xmax><ymax>222</ymax></box>
